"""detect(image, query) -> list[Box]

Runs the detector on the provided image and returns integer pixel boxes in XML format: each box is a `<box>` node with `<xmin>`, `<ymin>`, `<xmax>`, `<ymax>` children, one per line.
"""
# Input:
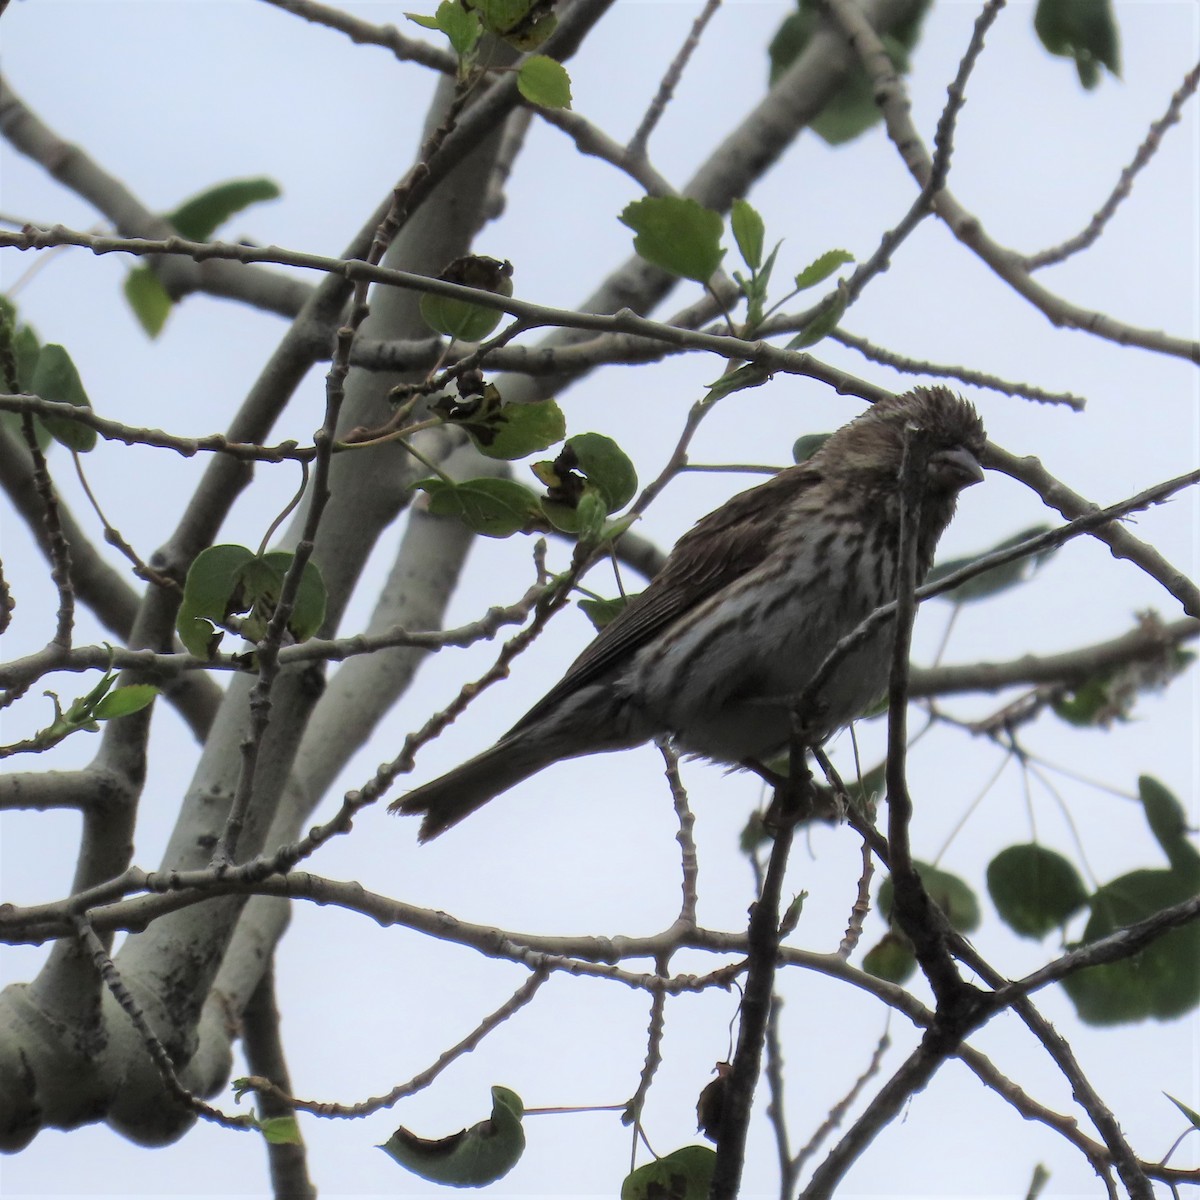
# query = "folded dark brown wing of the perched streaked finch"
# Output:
<box><xmin>509</xmin><ymin>463</ymin><xmax>822</xmax><ymax>733</ymax></box>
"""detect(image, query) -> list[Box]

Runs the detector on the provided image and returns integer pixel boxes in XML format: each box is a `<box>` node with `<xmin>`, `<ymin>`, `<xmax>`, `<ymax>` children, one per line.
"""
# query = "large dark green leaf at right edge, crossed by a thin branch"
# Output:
<box><xmin>1063</xmin><ymin>870</ymin><xmax>1200</xmax><ymax>1025</ymax></box>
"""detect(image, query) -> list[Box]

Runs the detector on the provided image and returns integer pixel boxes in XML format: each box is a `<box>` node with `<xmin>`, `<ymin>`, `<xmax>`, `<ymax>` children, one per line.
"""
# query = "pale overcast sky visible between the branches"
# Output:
<box><xmin>0</xmin><ymin>0</ymin><xmax>1200</xmax><ymax>1198</ymax></box>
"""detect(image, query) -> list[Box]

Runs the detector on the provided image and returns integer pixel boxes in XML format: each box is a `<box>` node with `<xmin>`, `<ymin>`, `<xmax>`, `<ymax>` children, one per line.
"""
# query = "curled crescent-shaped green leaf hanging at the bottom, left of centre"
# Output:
<box><xmin>379</xmin><ymin>1087</ymin><xmax>524</xmax><ymax>1188</ymax></box>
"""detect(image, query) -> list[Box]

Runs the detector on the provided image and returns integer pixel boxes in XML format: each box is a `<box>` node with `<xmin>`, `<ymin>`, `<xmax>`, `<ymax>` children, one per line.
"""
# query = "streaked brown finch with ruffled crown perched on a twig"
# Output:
<box><xmin>390</xmin><ymin>388</ymin><xmax>985</xmax><ymax>841</ymax></box>
